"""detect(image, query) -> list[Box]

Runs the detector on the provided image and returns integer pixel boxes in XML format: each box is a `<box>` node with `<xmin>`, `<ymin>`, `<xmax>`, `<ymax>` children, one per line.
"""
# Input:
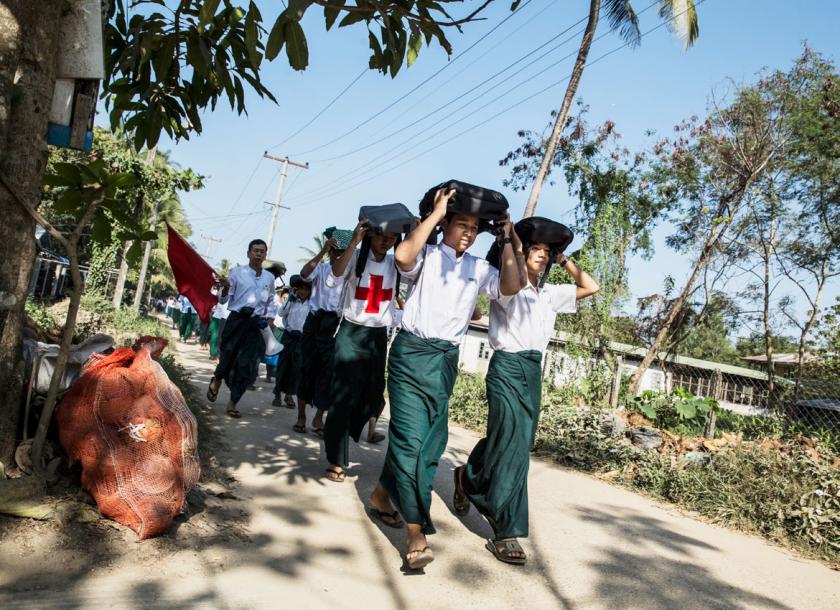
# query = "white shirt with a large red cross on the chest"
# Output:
<box><xmin>332</xmin><ymin>250</ymin><xmax>397</xmax><ymax>328</ymax></box>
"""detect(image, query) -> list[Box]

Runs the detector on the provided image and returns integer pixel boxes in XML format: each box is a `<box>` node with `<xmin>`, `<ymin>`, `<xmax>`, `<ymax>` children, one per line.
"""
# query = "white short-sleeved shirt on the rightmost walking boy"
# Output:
<box><xmin>488</xmin><ymin>282</ymin><xmax>577</xmax><ymax>352</ymax></box>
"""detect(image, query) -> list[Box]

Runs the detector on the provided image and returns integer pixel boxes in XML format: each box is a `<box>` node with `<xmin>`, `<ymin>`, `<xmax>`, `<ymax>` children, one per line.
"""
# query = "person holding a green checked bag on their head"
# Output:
<box><xmin>293</xmin><ymin>231</ymin><xmax>349</xmax><ymax>436</ymax></box>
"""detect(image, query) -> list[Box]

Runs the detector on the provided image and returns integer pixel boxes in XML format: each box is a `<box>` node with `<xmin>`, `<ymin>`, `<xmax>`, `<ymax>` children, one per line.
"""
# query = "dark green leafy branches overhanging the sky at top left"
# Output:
<box><xmin>103</xmin><ymin>0</ymin><xmax>498</xmax><ymax>150</ymax></box>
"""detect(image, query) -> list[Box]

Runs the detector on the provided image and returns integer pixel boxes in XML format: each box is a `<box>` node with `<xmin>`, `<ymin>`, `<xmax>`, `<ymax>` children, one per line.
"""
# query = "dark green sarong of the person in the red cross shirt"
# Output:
<box><xmin>324</xmin><ymin>320</ymin><xmax>388</xmax><ymax>468</ymax></box>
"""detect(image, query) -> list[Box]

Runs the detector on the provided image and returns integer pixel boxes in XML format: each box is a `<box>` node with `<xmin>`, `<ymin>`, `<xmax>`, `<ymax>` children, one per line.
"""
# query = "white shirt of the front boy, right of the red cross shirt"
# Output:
<box><xmin>402</xmin><ymin>244</ymin><xmax>501</xmax><ymax>344</ymax></box>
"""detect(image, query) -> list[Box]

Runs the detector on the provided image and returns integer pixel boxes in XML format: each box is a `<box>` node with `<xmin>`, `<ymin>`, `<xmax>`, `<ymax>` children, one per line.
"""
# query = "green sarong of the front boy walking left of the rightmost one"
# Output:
<box><xmin>379</xmin><ymin>331</ymin><xmax>458</xmax><ymax>534</ymax></box>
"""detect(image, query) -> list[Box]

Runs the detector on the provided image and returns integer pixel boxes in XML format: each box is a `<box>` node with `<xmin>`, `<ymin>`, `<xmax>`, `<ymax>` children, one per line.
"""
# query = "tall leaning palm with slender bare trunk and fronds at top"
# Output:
<box><xmin>523</xmin><ymin>0</ymin><xmax>700</xmax><ymax>218</ymax></box>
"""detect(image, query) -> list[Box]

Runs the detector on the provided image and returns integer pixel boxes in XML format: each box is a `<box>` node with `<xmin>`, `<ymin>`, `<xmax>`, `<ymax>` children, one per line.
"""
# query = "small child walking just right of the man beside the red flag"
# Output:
<box><xmin>271</xmin><ymin>275</ymin><xmax>311</xmax><ymax>409</ymax></box>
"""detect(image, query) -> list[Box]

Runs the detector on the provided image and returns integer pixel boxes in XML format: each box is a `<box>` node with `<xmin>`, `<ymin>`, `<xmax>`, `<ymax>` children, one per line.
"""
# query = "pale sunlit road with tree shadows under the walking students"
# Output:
<box><xmin>0</xmin><ymin>338</ymin><xmax>840</xmax><ymax>610</ymax></box>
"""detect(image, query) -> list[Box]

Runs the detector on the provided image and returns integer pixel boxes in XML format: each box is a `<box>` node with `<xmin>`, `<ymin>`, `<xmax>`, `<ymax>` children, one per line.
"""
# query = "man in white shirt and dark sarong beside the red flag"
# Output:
<box><xmin>207</xmin><ymin>239</ymin><xmax>274</xmax><ymax>417</ymax></box>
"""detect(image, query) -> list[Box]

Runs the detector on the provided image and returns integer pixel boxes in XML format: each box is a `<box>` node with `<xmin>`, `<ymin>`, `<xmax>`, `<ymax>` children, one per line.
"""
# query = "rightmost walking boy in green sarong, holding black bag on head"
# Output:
<box><xmin>453</xmin><ymin>218</ymin><xmax>598</xmax><ymax>565</ymax></box>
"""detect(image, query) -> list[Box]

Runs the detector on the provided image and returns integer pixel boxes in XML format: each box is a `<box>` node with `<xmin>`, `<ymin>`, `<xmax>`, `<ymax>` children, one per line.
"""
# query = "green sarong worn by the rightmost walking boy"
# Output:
<box><xmin>464</xmin><ymin>350</ymin><xmax>542</xmax><ymax>539</ymax></box>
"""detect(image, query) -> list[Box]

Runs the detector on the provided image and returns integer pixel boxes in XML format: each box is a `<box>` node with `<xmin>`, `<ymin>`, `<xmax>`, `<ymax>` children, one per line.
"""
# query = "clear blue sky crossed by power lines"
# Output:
<box><xmin>154</xmin><ymin>0</ymin><xmax>840</xmax><ymax>332</ymax></box>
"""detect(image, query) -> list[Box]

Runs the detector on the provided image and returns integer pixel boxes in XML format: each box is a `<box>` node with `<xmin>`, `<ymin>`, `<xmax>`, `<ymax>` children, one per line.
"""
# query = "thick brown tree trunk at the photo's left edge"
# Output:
<box><xmin>0</xmin><ymin>0</ymin><xmax>64</xmax><ymax>464</ymax></box>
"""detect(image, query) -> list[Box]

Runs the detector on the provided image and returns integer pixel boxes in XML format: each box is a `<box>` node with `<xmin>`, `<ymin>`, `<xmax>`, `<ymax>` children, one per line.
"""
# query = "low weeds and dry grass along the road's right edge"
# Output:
<box><xmin>449</xmin><ymin>374</ymin><xmax>840</xmax><ymax>565</ymax></box>
